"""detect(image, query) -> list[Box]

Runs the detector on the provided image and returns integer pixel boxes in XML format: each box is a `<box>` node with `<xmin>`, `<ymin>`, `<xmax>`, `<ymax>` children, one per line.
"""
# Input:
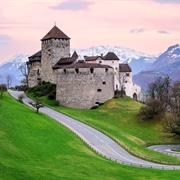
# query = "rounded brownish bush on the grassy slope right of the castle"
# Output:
<box><xmin>138</xmin><ymin>99</ymin><xmax>165</xmax><ymax>119</ymax></box>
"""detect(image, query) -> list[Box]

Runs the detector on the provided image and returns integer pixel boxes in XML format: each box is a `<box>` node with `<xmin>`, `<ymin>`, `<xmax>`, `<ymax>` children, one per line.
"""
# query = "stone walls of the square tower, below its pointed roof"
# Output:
<box><xmin>41</xmin><ymin>39</ymin><xmax>70</xmax><ymax>83</ymax></box>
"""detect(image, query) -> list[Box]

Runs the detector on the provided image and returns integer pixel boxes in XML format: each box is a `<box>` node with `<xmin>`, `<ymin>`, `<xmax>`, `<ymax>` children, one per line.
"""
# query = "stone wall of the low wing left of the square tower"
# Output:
<box><xmin>28</xmin><ymin>62</ymin><xmax>41</xmax><ymax>87</ymax></box>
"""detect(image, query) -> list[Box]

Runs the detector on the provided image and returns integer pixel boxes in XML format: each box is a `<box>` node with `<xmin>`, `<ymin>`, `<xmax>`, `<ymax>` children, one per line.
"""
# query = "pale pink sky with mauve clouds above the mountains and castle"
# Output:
<box><xmin>0</xmin><ymin>0</ymin><xmax>180</xmax><ymax>64</ymax></box>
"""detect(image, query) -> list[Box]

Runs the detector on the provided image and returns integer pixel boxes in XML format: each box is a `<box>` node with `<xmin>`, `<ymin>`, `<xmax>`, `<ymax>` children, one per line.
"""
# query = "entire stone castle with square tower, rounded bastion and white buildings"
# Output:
<box><xmin>27</xmin><ymin>26</ymin><xmax>141</xmax><ymax>109</ymax></box>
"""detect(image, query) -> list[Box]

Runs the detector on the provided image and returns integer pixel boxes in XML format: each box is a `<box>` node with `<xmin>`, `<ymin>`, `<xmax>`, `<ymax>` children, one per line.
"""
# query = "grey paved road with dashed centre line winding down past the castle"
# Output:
<box><xmin>8</xmin><ymin>90</ymin><xmax>180</xmax><ymax>169</ymax></box>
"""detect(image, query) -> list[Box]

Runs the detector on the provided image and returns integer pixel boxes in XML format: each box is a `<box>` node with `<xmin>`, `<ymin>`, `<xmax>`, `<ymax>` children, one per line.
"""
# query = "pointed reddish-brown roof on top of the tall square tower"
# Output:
<box><xmin>41</xmin><ymin>26</ymin><xmax>70</xmax><ymax>41</ymax></box>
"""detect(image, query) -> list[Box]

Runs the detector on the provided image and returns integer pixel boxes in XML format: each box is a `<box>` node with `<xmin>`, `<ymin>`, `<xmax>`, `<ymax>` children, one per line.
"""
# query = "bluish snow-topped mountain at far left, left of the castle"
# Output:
<box><xmin>0</xmin><ymin>54</ymin><xmax>28</xmax><ymax>87</ymax></box>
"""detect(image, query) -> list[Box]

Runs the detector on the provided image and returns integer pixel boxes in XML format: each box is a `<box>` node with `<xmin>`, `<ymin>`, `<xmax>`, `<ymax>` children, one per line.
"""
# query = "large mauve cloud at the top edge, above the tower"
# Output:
<box><xmin>50</xmin><ymin>0</ymin><xmax>93</xmax><ymax>11</ymax></box>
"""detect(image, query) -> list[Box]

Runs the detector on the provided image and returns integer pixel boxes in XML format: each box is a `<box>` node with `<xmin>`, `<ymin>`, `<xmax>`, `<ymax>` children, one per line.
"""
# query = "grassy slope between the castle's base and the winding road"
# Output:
<box><xmin>27</xmin><ymin>93</ymin><xmax>180</xmax><ymax>164</ymax></box>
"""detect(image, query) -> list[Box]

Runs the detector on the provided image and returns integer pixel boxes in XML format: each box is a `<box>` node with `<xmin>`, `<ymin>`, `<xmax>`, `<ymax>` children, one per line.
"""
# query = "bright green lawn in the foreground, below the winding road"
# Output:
<box><xmin>0</xmin><ymin>94</ymin><xmax>180</xmax><ymax>180</ymax></box>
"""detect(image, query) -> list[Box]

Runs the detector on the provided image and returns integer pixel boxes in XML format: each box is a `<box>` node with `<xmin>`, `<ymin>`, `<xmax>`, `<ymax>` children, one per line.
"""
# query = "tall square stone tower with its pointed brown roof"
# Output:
<box><xmin>41</xmin><ymin>26</ymin><xmax>70</xmax><ymax>83</ymax></box>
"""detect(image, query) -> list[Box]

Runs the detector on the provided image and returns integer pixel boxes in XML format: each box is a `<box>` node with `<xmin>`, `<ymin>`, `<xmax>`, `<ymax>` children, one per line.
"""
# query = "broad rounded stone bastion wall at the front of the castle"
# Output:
<box><xmin>56</xmin><ymin>68</ymin><xmax>114</xmax><ymax>109</ymax></box>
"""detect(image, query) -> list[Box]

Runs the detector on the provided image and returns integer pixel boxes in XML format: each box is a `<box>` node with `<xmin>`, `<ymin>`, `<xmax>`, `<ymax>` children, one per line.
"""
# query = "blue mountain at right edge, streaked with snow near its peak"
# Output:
<box><xmin>133</xmin><ymin>44</ymin><xmax>180</xmax><ymax>90</ymax></box>
